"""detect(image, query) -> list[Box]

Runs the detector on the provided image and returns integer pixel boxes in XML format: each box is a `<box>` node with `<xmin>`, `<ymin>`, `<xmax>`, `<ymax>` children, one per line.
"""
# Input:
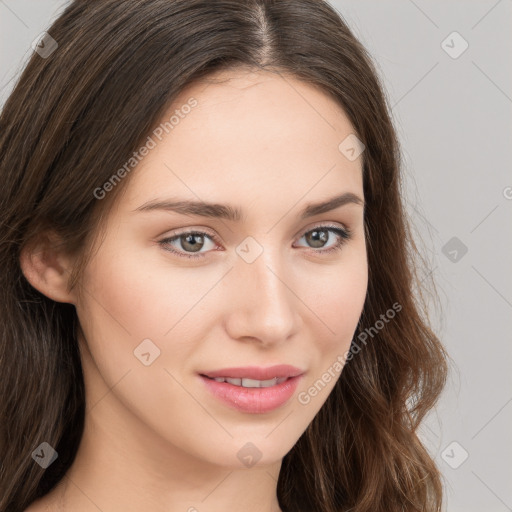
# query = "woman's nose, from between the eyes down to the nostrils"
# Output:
<box><xmin>226</xmin><ymin>250</ymin><xmax>301</xmax><ymax>346</ymax></box>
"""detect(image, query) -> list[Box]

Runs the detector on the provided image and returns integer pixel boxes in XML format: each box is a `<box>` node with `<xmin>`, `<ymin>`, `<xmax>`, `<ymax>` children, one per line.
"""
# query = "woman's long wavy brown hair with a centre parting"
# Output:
<box><xmin>0</xmin><ymin>0</ymin><xmax>447</xmax><ymax>512</ymax></box>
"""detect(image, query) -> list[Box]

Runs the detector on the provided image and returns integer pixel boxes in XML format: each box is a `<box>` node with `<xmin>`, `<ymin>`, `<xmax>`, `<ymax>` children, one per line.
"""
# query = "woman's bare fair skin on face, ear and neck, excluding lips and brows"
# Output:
<box><xmin>21</xmin><ymin>71</ymin><xmax>368</xmax><ymax>512</ymax></box>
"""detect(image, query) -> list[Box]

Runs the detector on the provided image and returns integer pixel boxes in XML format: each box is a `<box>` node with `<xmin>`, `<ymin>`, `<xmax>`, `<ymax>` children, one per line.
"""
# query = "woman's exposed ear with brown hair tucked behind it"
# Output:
<box><xmin>20</xmin><ymin>232</ymin><xmax>76</xmax><ymax>304</ymax></box>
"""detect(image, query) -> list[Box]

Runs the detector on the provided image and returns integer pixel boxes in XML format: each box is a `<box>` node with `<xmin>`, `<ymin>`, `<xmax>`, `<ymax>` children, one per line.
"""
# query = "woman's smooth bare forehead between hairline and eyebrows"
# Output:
<box><xmin>120</xmin><ymin>70</ymin><xmax>362</xmax><ymax>212</ymax></box>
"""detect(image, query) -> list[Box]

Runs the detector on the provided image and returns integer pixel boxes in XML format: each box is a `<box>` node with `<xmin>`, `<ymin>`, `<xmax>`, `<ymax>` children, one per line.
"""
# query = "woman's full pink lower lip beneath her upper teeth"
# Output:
<box><xmin>200</xmin><ymin>375</ymin><xmax>302</xmax><ymax>414</ymax></box>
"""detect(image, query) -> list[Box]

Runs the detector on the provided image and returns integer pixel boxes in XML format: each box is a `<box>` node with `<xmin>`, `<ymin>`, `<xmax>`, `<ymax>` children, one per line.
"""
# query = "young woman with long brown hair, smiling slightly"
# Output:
<box><xmin>0</xmin><ymin>0</ymin><xmax>446</xmax><ymax>512</ymax></box>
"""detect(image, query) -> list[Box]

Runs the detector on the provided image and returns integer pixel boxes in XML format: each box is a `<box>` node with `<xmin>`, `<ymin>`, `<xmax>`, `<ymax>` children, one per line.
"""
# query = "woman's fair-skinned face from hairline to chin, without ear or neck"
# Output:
<box><xmin>76</xmin><ymin>71</ymin><xmax>368</xmax><ymax>467</ymax></box>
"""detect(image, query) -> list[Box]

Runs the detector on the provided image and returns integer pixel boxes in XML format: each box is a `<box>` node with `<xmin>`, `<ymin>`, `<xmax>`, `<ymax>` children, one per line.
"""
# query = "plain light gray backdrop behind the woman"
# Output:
<box><xmin>0</xmin><ymin>0</ymin><xmax>512</xmax><ymax>512</ymax></box>
